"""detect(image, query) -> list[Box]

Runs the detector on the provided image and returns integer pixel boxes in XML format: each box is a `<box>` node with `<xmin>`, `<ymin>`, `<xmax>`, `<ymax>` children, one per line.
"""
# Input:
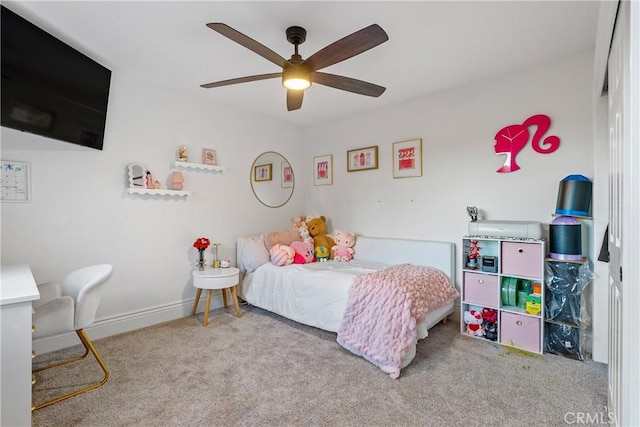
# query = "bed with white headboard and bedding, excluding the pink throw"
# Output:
<box><xmin>237</xmin><ymin>235</ymin><xmax>457</xmax><ymax>378</ymax></box>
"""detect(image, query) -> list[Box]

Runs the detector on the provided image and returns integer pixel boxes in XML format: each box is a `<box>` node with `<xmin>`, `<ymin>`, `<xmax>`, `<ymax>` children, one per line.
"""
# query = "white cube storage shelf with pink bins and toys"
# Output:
<box><xmin>460</xmin><ymin>236</ymin><xmax>546</xmax><ymax>354</ymax></box>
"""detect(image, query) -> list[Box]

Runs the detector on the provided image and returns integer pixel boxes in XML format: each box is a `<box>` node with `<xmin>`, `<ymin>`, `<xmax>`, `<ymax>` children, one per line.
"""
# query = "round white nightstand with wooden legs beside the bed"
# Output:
<box><xmin>191</xmin><ymin>267</ymin><xmax>242</xmax><ymax>326</ymax></box>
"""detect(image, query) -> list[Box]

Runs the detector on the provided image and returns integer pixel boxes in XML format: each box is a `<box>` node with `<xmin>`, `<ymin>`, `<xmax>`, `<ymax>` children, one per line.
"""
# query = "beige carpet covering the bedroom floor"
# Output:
<box><xmin>33</xmin><ymin>306</ymin><xmax>607</xmax><ymax>427</ymax></box>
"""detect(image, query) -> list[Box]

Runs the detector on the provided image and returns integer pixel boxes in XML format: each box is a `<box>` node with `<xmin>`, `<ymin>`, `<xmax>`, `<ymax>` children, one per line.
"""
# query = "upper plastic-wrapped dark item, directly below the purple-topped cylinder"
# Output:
<box><xmin>545</xmin><ymin>261</ymin><xmax>594</xmax><ymax>328</ymax></box>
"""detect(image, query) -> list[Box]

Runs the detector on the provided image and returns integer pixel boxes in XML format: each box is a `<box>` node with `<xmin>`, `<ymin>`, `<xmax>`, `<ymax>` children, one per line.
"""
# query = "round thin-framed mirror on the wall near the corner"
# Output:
<box><xmin>249</xmin><ymin>151</ymin><xmax>295</xmax><ymax>208</ymax></box>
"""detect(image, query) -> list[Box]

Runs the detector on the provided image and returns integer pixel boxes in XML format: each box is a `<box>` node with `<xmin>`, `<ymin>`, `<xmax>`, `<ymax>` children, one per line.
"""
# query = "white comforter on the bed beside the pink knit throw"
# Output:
<box><xmin>241</xmin><ymin>260</ymin><xmax>387</xmax><ymax>332</ymax></box>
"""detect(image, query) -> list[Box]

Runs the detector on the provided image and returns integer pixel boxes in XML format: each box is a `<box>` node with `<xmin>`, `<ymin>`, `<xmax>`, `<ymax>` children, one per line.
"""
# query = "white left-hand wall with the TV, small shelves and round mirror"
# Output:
<box><xmin>1</xmin><ymin>70</ymin><xmax>304</xmax><ymax>350</ymax></box>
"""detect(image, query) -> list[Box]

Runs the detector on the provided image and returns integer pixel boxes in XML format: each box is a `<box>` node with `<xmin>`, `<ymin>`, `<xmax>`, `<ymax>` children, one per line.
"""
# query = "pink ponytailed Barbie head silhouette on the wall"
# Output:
<box><xmin>493</xmin><ymin>114</ymin><xmax>560</xmax><ymax>173</ymax></box>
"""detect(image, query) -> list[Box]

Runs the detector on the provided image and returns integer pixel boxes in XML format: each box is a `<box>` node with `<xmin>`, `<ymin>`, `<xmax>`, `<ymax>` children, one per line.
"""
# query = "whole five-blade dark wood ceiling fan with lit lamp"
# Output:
<box><xmin>200</xmin><ymin>23</ymin><xmax>389</xmax><ymax>111</ymax></box>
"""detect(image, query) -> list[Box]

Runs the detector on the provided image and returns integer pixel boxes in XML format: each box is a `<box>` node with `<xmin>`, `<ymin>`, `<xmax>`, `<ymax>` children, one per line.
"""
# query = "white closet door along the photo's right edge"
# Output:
<box><xmin>608</xmin><ymin>1</ymin><xmax>640</xmax><ymax>426</ymax></box>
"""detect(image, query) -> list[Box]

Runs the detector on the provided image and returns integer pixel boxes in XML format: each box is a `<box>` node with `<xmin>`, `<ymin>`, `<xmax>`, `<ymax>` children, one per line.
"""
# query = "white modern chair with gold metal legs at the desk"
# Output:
<box><xmin>32</xmin><ymin>264</ymin><xmax>113</xmax><ymax>411</ymax></box>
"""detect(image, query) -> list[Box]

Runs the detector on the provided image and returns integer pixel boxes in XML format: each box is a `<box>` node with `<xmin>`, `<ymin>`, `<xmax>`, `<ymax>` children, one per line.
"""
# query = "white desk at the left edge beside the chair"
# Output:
<box><xmin>0</xmin><ymin>264</ymin><xmax>40</xmax><ymax>426</ymax></box>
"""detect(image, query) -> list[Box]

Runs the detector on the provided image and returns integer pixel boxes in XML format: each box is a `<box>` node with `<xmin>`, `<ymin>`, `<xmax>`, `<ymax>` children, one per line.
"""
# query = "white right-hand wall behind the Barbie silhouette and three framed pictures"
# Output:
<box><xmin>305</xmin><ymin>51</ymin><xmax>594</xmax><ymax>298</ymax></box>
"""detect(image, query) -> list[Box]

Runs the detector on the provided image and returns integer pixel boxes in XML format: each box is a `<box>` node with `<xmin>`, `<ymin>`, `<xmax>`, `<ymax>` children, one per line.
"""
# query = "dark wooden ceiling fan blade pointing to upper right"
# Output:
<box><xmin>304</xmin><ymin>24</ymin><xmax>389</xmax><ymax>71</ymax></box>
